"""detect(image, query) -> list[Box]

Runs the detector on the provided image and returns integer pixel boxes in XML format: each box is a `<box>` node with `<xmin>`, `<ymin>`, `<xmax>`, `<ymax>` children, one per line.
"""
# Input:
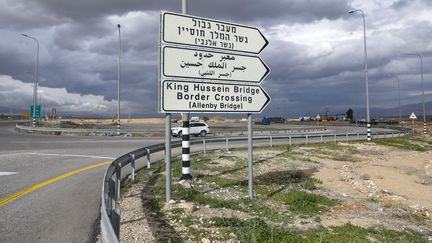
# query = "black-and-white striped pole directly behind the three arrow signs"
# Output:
<box><xmin>180</xmin><ymin>0</ymin><xmax>192</xmax><ymax>180</ymax></box>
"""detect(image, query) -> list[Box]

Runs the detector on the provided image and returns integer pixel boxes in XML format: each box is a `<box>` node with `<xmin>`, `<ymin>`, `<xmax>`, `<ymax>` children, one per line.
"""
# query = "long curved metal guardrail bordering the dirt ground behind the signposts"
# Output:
<box><xmin>100</xmin><ymin>130</ymin><xmax>412</xmax><ymax>243</ymax></box>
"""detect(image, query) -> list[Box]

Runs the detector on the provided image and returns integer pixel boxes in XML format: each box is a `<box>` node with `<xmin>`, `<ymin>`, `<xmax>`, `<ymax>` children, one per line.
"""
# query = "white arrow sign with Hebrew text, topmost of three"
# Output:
<box><xmin>162</xmin><ymin>12</ymin><xmax>268</xmax><ymax>54</ymax></box>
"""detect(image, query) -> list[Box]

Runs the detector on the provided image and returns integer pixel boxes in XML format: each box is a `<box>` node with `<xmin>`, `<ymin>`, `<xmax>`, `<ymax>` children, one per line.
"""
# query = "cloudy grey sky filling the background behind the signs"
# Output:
<box><xmin>0</xmin><ymin>0</ymin><xmax>432</xmax><ymax>116</ymax></box>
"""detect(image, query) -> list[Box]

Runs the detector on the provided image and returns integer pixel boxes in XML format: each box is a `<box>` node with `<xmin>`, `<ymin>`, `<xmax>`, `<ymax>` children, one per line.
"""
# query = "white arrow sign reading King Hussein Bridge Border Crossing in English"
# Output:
<box><xmin>161</xmin><ymin>80</ymin><xmax>270</xmax><ymax>113</ymax></box>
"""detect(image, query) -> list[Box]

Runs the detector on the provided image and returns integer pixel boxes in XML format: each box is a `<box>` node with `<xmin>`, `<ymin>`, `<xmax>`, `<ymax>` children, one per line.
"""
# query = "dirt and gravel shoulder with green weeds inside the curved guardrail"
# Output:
<box><xmin>120</xmin><ymin>137</ymin><xmax>432</xmax><ymax>242</ymax></box>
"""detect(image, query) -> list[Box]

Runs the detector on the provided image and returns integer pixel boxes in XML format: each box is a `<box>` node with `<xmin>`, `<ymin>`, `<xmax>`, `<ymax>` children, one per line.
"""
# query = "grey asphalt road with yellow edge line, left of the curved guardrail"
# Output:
<box><xmin>0</xmin><ymin>122</ymin><xmax>398</xmax><ymax>242</ymax></box>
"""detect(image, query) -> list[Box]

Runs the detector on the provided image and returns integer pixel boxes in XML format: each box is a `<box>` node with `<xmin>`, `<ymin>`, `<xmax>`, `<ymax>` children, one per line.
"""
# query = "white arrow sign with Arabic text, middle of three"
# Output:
<box><xmin>162</xmin><ymin>46</ymin><xmax>270</xmax><ymax>83</ymax></box>
